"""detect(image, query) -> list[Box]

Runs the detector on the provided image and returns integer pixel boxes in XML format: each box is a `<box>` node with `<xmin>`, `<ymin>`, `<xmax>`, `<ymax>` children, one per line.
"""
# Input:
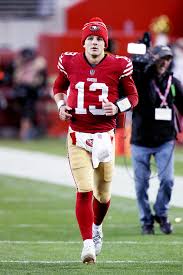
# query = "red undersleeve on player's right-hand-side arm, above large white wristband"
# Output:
<box><xmin>120</xmin><ymin>76</ymin><xmax>138</xmax><ymax>107</ymax></box>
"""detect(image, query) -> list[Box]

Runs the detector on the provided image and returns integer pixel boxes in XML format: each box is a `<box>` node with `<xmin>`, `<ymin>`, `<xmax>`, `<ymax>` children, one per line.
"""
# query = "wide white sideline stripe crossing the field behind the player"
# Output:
<box><xmin>0</xmin><ymin>147</ymin><xmax>183</xmax><ymax>207</ymax></box>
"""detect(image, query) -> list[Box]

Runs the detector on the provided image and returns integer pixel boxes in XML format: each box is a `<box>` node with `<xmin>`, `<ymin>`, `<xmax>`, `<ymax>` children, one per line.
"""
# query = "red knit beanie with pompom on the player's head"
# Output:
<box><xmin>81</xmin><ymin>17</ymin><xmax>108</xmax><ymax>48</ymax></box>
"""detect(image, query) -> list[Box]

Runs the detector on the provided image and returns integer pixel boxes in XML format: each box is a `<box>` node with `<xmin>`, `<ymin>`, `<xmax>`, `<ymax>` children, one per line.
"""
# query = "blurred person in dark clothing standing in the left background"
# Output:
<box><xmin>13</xmin><ymin>48</ymin><xmax>47</xmax><ymax>140</ymax></box>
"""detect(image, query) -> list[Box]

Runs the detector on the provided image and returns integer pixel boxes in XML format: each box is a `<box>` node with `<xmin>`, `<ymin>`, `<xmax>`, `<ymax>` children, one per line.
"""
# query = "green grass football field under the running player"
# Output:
<box><xmin>0</xmin><ymin>139</ymin><xmax>183</xmax><ymax>275</ymax></box>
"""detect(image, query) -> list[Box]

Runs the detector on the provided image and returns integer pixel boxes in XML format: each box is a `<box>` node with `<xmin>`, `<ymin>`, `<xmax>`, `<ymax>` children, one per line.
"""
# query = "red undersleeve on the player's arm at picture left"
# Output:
<box><xmin>53</xmin><ymin>73</ymin><xmax>70</xmax><ymax>95</ymax></box>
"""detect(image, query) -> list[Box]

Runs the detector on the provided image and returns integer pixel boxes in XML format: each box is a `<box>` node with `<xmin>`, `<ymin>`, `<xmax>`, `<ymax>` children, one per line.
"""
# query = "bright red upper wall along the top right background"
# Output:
<box><xmin>67</xmin><ymin>0</ymin><xmax>183</xmax><ymax>36</ymax></box>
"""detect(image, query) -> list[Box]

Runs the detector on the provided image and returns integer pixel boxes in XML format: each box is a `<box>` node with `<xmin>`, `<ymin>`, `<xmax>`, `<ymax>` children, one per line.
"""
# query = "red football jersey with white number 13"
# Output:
<box><xmin>53</xmin><ymin>52</ymin><xmax>138</xmax><ymax>133</ymax></box>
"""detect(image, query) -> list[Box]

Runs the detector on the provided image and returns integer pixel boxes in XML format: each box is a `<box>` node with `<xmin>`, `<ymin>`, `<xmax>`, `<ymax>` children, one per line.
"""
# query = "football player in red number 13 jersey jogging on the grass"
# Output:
<box><xmin>53</xmin><ymin>17</ymin><xmax>138</xmax><ymax>263</ymax></box>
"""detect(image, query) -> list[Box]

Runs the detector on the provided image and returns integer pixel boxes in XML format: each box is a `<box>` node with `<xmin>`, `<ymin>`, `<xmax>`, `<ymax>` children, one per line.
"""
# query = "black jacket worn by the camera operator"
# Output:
<box><xmin>131</xmin><ymin>61</ymin><xmax>183</xmax><ymax>147</ymax></box>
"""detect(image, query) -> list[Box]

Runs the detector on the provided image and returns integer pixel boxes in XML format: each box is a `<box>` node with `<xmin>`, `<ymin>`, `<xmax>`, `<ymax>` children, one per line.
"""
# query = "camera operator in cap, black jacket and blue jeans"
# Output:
<box><xmin>131</xmin><ymin>40</ymin><xmax>183</xmax><ymax>234</ymax></box>
